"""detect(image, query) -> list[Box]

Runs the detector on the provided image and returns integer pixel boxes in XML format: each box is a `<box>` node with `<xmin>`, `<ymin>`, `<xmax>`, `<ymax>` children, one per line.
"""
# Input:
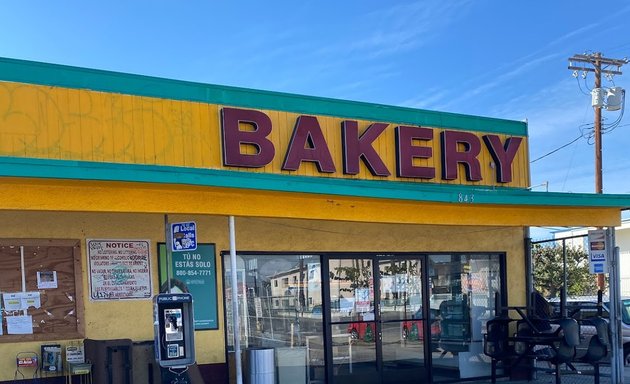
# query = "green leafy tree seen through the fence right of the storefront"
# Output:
<box><xmin>532</xmin><ymin>243</ymin><xmax>597</xmax><ymax>298</ymax></box>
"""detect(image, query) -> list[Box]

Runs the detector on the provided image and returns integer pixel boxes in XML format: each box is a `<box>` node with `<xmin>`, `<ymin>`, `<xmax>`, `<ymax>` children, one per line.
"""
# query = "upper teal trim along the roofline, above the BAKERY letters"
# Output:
<box><xmin>0</xmin><ymin>58</ymin><xmax>527</xmax><ymax>136</ymax></box>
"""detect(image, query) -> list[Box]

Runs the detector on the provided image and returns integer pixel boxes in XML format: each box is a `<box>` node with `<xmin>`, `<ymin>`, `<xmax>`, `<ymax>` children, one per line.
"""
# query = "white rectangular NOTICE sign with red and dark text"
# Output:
<box><xmin>87</xmin><ymin>239</ymin><xmax>153</xmax><ymax>300</ymax></box>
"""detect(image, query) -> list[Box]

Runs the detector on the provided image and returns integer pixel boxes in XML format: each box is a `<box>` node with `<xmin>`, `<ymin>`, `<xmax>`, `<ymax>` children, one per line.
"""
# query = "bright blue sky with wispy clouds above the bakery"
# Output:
<box><xmin>0</xmin><ymin>0</ymin><xmax>630</xmax><ymax>201</ymax></box>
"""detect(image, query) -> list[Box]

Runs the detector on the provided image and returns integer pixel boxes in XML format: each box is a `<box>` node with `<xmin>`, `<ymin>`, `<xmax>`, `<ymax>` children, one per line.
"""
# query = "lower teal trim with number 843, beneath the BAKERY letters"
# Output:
<box><xmin>0</xmin><ymin>157</ymin><xmax>630</xmax><ymax>209</ymax></box>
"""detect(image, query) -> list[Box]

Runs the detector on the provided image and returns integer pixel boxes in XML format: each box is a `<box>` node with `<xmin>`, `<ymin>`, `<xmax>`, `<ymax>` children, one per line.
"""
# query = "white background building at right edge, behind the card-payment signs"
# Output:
<box><xmin>553</xmin><ymin>218</ymin><xmax>630</xmax><ymax>297</ymax></box>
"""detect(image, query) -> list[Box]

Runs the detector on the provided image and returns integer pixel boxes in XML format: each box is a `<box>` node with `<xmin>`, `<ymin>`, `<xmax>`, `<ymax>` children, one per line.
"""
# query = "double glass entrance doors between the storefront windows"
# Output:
<box><xmin>325</xmin><ymin>255</ymin><xmax>429</xmax><ymax>384</ymax></box>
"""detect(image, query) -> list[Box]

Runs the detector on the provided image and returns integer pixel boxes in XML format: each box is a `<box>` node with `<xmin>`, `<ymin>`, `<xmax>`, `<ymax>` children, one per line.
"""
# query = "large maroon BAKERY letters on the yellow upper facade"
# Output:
<box><xmin>221</xmin><ymin>107</ymin><xmax>526</xmax><ymax>184</ymax></box>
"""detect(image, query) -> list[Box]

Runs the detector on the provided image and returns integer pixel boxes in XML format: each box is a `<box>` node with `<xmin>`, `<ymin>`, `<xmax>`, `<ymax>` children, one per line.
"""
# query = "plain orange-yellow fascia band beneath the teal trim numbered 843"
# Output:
<box><xmin>0</xmin><ymin>178</ymin><xmax>620</xmax><ymax>226</ymax></box>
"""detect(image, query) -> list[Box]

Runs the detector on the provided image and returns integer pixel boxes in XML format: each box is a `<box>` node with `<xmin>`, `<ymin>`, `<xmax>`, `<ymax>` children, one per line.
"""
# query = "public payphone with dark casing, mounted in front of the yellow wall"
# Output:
<box><xmin>153</xmin><ymin>293</ymin><xmax>195</xmax><ymax>368</ymax></box>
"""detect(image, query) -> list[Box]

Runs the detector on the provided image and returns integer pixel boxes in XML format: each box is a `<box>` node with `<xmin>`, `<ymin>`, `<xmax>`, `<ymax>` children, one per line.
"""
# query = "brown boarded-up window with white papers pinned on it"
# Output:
<box><xmin>0</xmin><ymin>239</ymin><xmax>85</xmax><ymax>342</ymax></box>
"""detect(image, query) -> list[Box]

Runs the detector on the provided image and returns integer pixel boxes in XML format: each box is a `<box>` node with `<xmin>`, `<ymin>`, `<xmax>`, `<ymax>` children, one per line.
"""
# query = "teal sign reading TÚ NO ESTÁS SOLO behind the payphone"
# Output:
<box><xmin>159</xmin><ymin>244</ymin><xmax>219</xmax><ymax>330</ymax></box>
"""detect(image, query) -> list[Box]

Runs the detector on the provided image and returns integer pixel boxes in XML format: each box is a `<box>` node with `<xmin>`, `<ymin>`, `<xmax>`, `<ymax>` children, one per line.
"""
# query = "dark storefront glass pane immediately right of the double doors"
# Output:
<box><xmin>429</xmin><ymin>254</ymin><xmax>501</xmax><ymax>382</ymax></box>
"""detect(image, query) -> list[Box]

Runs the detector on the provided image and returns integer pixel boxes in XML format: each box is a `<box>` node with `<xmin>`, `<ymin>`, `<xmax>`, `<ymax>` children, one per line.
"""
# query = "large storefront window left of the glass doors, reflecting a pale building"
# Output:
<box><xmin>223</xmin><ymin>255</ymin><xmax>324</xmax><ymax>384</ymax></box>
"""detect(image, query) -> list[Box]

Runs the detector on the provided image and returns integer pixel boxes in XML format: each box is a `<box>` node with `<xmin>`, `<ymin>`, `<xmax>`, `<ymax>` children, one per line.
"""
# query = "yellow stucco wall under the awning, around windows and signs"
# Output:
<box><xmin>0</xmin><ymin>211</ymin><xmax>525</xmax><ymax>381</ymax></box>
